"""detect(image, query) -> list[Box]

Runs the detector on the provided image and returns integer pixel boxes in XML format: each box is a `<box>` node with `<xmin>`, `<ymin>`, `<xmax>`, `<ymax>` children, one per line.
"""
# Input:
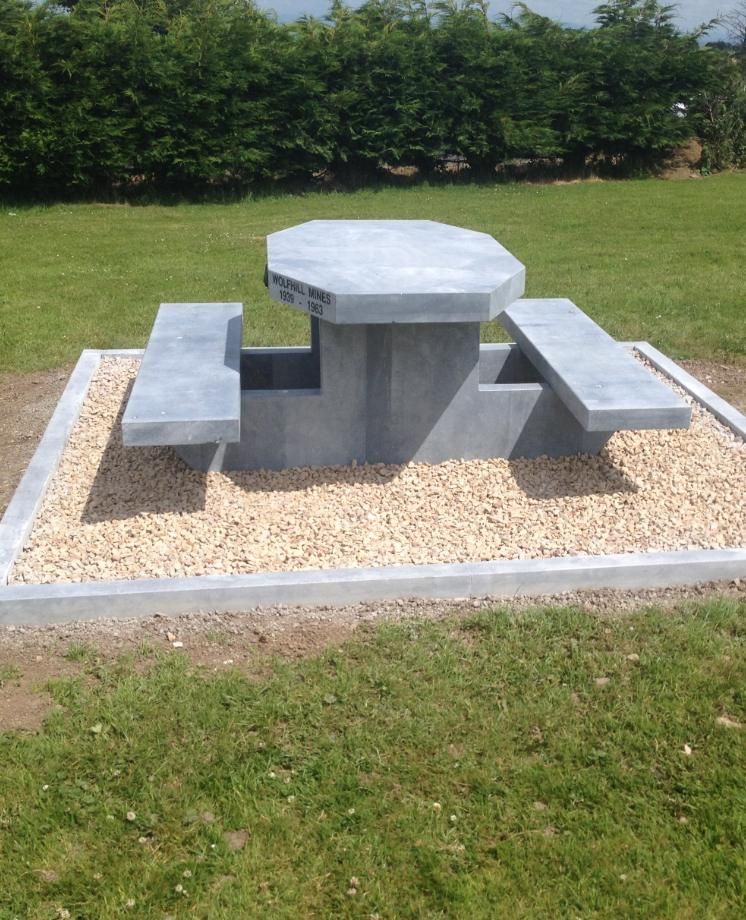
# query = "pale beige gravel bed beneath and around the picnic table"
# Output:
<box><xmin>10</xmin><ymin>358</ymin><xmax>746</xmax><ymax>583</ymax></box>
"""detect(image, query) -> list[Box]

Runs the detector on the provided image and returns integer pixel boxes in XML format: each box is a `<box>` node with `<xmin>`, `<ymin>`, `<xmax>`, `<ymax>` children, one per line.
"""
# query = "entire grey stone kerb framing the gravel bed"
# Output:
<box><xmin>0</xmin><ymin>342</ymin><xmax>746</xmax><ymax>624</ymax></box>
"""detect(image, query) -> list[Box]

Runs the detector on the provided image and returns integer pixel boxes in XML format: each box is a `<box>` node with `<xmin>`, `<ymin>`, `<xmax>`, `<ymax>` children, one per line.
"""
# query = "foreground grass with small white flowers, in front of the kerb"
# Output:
<box><xmin>0</xmin><ymin>601</ymin><xmax>746</xmax><ymax>920</ymax></box>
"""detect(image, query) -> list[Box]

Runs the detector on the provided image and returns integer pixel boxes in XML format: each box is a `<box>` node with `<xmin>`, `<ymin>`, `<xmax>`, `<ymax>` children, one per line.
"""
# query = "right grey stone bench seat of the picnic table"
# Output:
<box><xmin>498</xmin><ymin>299</ymin><xmax>691</xmax><ymax>431</ymax></box>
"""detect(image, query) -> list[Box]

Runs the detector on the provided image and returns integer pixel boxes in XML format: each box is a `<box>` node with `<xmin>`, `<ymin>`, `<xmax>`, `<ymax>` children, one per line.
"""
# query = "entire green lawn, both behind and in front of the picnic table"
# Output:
<box><xmin>0</xmin><ymin>174</ymin><xmax>746</xmax><ymax>920</ymax></box>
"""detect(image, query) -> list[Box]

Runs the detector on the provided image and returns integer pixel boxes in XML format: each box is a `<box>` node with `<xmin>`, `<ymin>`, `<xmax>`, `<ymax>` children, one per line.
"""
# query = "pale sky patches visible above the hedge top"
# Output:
<box><xmin>257</xmin><ymin>0</ymin><xmax>738</xmax><ymax>39</ymax></box>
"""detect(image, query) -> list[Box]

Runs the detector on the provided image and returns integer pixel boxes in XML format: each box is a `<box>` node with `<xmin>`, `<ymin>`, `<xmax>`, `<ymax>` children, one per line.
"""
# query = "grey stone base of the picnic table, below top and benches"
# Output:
<box><xmin>177</xmin><ymin>323</ymin><xmax>608</xmax><ymax>471</ymax></box>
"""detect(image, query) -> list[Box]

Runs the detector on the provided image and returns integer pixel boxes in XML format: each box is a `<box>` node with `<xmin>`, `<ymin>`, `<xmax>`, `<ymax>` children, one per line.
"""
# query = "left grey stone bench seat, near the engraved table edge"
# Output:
<box><xmin>122</xmin><ymin>303</ymin><xmax>243</xmax><ymax>447</ymax></box>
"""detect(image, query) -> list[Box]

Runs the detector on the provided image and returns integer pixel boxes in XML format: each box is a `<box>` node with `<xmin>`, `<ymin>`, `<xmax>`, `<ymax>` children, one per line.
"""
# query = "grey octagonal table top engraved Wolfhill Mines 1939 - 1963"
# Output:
<box><xmin>267</xmin><ymin>220</ymin><xmax>526</xmax><ymax>323</ymax></box>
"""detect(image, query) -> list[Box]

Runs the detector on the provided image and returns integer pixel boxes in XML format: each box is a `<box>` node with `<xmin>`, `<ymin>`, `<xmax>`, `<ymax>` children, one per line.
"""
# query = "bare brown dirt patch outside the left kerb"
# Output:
<box><xmin>0</xmin><ymin>368</ymin><xmax>71</xmax><ymax>515</ymax></box>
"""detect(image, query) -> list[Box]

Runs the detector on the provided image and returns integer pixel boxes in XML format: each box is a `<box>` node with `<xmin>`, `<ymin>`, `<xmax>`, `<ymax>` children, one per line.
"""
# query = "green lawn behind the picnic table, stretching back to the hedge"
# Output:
<box><xmin>0</xmin><ymin>174</ymin><xmax>746</xmax><ymax>370</ymax></box>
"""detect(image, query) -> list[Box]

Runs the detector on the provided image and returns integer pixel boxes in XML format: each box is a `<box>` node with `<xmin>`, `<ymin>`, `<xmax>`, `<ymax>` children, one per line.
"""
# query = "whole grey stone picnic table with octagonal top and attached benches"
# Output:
<box><xmin>123</xmin><ymin>220</ymin><xmax>690</xmax><ymax>469</ymax></box>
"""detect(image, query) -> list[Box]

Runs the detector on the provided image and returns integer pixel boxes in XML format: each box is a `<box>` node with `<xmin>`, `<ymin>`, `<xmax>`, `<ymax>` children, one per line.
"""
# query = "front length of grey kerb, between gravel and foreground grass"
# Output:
<box><xmin>0</xmin><ymin>549</ymin><xmax>746</xmax><ymax>625</ymax></box>
